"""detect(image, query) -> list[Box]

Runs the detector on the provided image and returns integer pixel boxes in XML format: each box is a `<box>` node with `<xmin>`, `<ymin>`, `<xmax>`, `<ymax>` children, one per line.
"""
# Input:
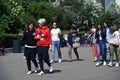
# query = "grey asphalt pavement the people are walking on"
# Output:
<box><xmin>0</xmin><ymin>47</ymin><xmax>120</xmax><ymax>80</ymax></box>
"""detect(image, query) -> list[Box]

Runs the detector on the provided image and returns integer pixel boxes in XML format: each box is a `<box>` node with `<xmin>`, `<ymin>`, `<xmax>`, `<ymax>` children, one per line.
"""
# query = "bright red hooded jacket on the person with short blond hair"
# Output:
<box><xmin>34</xmin><ymin>25</ymin><xmax>52</xmax><ymax>46</ymax></box>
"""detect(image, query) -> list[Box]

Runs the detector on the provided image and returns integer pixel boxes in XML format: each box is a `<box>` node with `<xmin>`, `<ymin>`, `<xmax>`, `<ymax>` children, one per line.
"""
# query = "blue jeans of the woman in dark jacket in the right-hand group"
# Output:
<box><xmin>97</xmin><ymin>40</ymin><xmax>107</xmax><ymax>62</ymax></box>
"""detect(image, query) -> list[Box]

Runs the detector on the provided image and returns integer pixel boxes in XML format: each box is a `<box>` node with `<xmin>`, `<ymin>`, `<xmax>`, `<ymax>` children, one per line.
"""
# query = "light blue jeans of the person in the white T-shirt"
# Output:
<box><xmin>51</xmin><ymin>41</ymin><xmax>61</xmax><ymax>60</ymax></box>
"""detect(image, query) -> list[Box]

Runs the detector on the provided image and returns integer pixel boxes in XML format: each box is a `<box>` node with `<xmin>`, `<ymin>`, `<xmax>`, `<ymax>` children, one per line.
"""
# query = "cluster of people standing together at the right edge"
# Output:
<box><xmin>90</xmin><ymin>22</ymin><xmax>120</xmax><ymax>67</ymax></box>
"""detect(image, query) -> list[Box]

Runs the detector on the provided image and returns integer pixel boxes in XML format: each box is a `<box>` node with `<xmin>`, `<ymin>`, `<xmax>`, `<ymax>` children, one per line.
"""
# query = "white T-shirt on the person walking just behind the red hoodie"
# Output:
<box><xmin>51</xmin><ymin>28</ymin><xmax>61</xmax><ymax>41</ymax></box>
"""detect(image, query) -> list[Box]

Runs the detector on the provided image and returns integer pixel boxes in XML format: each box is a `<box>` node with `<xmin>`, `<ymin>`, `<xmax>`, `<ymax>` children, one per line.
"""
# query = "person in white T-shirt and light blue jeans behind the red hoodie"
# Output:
<box><xmin>50</xmin><ymin>22</ymin><xmax>62</xmax><ymax>63</ymax></box>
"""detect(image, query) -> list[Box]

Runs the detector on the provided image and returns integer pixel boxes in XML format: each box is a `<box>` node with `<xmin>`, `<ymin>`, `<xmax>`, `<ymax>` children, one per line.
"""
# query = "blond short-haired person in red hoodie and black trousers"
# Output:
<box><xmin>34</xmin><ymin>18</ymin><xmax>53</xmax><ymax>75</ymax></box>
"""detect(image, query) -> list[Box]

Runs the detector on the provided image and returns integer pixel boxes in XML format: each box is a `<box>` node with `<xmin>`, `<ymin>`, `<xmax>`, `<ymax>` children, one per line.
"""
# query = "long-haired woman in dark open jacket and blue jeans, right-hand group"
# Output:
<box><xmin>95</xmin><ymin>24</ymin><xmax>107</xmax><ymax>66</ymax></box>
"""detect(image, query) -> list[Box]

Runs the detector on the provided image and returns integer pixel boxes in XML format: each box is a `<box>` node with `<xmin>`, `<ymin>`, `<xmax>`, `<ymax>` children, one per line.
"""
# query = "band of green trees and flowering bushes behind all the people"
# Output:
<box><xmin>0</xmin><ymin>0</ymin><xmax>120</xmax><ymax>47</ymax></box>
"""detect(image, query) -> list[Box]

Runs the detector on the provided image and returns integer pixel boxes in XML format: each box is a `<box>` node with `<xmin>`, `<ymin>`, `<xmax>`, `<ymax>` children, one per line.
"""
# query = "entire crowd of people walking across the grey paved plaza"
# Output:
<box><xmin>23</xmin><ymin>18</ymin><xmax>120</xmax><ymax>75</ymax></box>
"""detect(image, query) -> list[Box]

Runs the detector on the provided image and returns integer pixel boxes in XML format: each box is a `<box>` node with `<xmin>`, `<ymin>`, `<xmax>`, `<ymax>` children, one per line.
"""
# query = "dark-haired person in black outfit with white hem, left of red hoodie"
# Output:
<box><xmin>23</xmin><ymin>21</ymin><xmax>38</xmax><ymax>74</ymax></box>
